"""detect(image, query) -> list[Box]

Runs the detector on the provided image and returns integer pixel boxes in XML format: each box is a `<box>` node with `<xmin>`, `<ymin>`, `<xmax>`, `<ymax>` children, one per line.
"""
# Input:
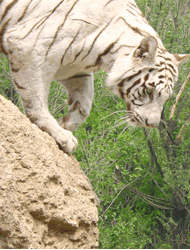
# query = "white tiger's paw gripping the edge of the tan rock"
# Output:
<box><xmin>53</xmin><ymin>129</ymin><xmax>78</xmax><ymax>153</ymax></box>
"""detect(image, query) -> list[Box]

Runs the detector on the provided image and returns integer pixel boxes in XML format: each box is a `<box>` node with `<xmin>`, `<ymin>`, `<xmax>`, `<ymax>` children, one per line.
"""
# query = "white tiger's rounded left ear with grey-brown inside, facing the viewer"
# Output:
<box><xmin>134</xmin><ymin>36</ymin><xmax>158</xmax><ymax>61</ymax></box>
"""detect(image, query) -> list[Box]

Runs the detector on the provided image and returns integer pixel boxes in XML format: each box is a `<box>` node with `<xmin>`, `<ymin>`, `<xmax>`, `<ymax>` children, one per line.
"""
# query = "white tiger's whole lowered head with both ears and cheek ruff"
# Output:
<box><xmin>107</xmin><ymin>37</ymin><xmax>190</xmax><ymax>127</ymax></box>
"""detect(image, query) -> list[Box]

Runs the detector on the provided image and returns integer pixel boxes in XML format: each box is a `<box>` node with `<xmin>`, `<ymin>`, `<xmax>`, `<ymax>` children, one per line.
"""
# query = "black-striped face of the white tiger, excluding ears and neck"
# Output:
<box><xmin>123</xmin><ymin>64</ymin><xmax>177</xmax><ymax>127</ymax></box>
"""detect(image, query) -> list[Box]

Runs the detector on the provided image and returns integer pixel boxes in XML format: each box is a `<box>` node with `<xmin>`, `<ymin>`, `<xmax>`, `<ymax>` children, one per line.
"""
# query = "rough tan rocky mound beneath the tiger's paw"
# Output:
<box><xmin>0</xmin><ymin>96</ymin><xmax>99</xmax><ymax>249</ymax></box>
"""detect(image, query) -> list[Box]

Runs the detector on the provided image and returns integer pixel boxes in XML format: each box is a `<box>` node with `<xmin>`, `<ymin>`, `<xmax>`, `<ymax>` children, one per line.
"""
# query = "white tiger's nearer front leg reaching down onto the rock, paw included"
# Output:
<box><xmin>8</xmin><ymin>36</ymin><xmax>78</xmax><ymax>153</ymax></box>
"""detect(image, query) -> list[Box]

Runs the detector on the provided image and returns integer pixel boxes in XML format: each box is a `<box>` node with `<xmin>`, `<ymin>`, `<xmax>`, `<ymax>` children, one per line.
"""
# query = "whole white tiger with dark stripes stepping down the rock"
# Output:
<box><xmin>0</xmin><ymin>0</ymin><xmax>189</xmax><ymax>153</ymax></box>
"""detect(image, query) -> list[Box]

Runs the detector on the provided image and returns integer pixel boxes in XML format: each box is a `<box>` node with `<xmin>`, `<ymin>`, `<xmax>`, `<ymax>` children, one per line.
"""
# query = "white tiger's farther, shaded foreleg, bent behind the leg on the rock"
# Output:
<box><xmin>58</xmin><ymin>73</ymin><xmax>94</xmax><ymax>131</ymax></box>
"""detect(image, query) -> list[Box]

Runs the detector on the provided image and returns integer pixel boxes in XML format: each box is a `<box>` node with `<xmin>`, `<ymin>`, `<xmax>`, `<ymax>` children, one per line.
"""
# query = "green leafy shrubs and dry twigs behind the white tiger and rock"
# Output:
<box><xmin>0</xmin><ymin>0</ymin><xmax>190</xmax><ymax>248</ymax></box>
